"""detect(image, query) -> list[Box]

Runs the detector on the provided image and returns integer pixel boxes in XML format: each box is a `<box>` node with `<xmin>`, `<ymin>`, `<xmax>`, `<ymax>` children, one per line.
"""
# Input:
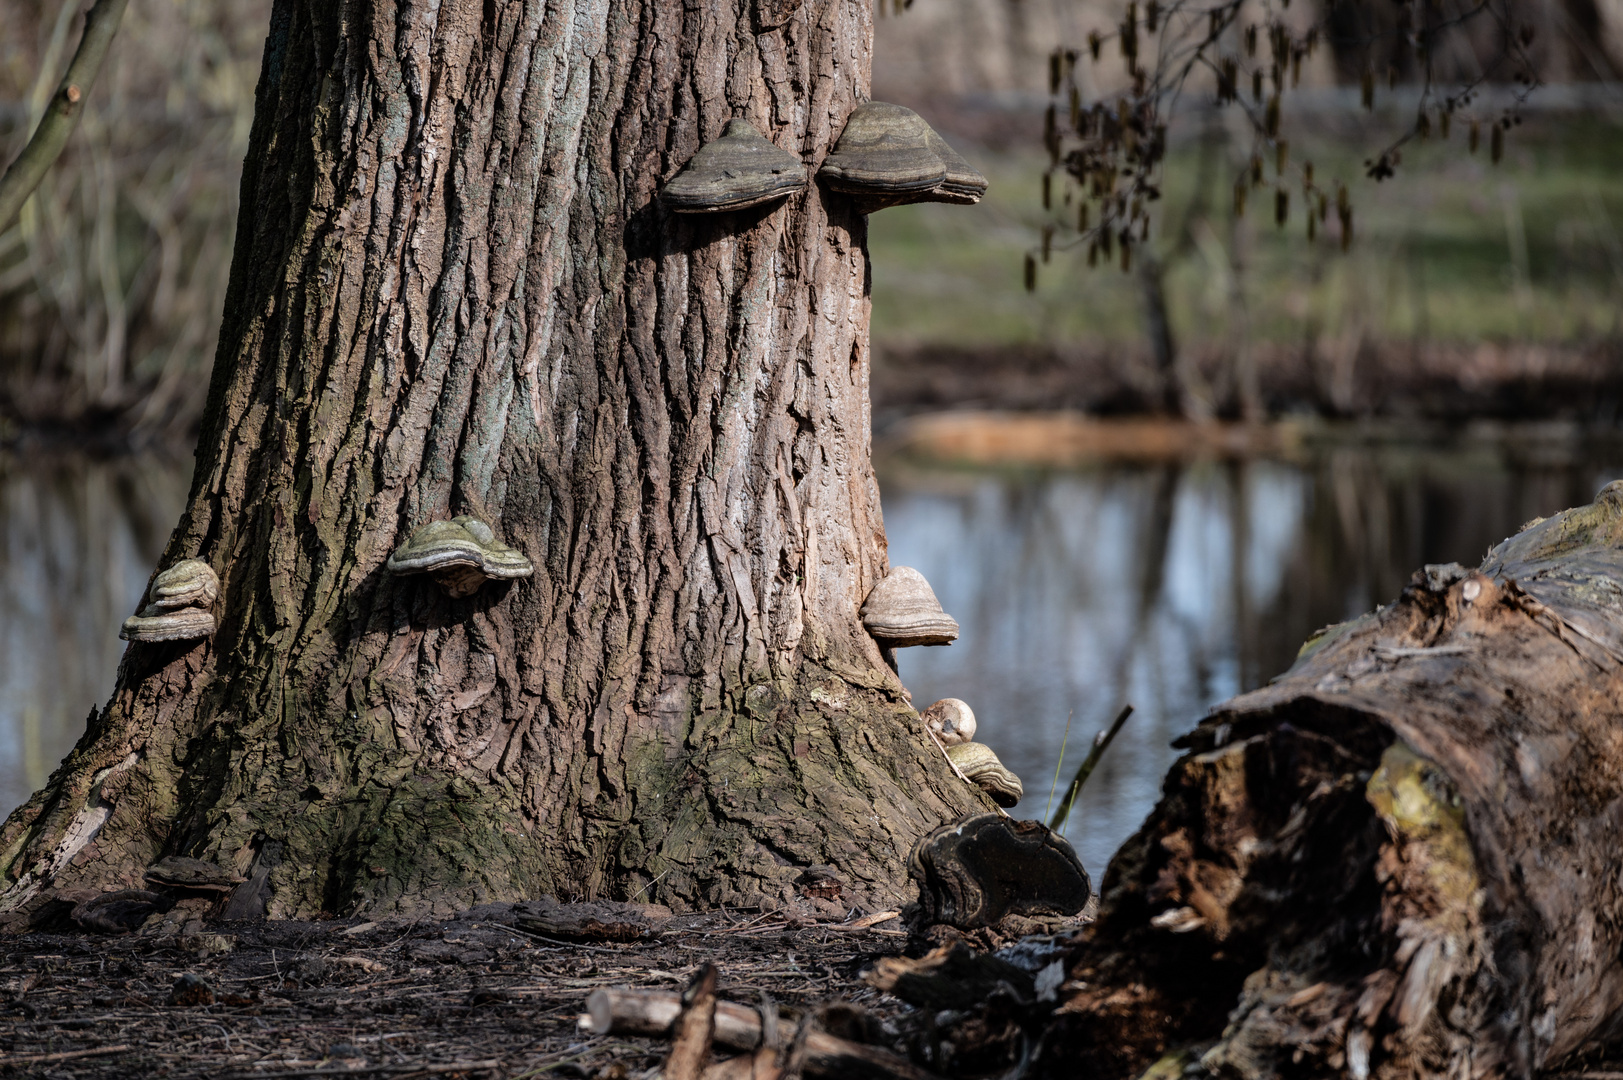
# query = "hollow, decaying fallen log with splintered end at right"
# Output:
<box><xmin>1040</xmin><ymin>482</ymin><xmax>1623</xmax><ymax>1080</ymax></box>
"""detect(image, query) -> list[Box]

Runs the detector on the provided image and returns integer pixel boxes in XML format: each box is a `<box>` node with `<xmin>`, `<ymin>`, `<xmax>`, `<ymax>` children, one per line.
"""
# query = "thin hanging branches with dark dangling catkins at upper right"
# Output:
<box><xmin>1024</xmin><ymin>0</ymin><xmax>1539</xmax><ymax>291</ymax></box>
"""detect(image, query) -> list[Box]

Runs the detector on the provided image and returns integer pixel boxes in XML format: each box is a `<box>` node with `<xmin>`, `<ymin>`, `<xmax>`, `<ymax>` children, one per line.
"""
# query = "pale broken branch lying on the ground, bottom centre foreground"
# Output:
<box><xmin>579</xmin><ymin>989</ymin><xmax>936</xmax><ymax>1080</ymax></box>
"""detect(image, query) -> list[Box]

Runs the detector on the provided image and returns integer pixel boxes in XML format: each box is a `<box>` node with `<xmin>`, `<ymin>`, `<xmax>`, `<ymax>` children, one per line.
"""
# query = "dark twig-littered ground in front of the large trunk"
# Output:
<box><xmin>0</xmin><ymin>905</ymin><xmax>928</xmax><ymax>1080</ymax></box>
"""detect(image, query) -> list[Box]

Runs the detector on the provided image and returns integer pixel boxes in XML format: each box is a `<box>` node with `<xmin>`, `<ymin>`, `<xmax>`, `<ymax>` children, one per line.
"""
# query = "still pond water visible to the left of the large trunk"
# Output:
<box><xmin>0</xmin><ymin>456</ymin><xmax>190</xmax><ymax>814</ymax></box>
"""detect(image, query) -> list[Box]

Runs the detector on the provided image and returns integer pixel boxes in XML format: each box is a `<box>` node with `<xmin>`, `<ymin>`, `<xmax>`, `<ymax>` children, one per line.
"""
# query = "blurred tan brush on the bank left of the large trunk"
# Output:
<box><xmin>0</xmin><ymin>0</ymin><xmax>259</xmax><ymax>440</ymax></box>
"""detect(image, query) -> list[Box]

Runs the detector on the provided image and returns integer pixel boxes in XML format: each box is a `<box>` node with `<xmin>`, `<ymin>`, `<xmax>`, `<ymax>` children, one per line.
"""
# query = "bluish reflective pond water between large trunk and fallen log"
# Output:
<box><xmin>881</xmin><ymin>445</ymin><xmax>1623</xmax><ymax>879</ymax></box>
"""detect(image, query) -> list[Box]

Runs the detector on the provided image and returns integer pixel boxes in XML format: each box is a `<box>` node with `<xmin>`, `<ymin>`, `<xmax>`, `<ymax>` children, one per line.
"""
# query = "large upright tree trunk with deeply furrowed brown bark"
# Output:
<box><xmin>0</xmin><ymin>0</ymin><xmax>987</xmax><ymax>924</ymax></box>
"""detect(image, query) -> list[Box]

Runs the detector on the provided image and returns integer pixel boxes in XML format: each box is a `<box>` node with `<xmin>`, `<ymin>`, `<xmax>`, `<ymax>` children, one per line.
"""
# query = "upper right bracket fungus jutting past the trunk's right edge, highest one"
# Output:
<box><xmin>818</xmin><ymin>101</ymin><xmax>987</xmax><ymax>213</ymax></box>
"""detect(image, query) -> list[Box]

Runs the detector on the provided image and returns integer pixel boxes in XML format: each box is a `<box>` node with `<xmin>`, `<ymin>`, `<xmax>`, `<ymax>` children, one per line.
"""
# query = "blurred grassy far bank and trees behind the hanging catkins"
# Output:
<box><xmin>873</xmin><ymin>0</ymin><xmax>1623</xmax><ymax>421</ymax></box>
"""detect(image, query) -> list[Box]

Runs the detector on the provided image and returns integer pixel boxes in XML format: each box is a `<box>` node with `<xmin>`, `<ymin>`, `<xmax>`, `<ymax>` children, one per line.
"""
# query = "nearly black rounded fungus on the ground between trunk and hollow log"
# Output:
<box><xmin>902</xmin><ymin>814</ymin><xmax>1092</xmax><ymax>931</ymax></box>
